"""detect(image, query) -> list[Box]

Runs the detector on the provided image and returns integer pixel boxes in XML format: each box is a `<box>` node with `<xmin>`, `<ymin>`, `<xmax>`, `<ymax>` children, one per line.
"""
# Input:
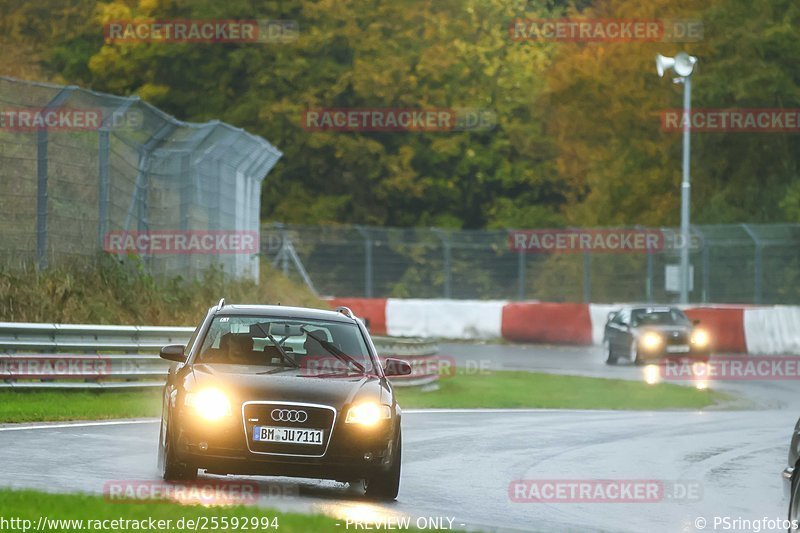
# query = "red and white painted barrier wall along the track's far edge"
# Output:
<box><xmin>331</xmin><ymin>298</ymin><xmax>800</xmax><ymax>355</ymax></box>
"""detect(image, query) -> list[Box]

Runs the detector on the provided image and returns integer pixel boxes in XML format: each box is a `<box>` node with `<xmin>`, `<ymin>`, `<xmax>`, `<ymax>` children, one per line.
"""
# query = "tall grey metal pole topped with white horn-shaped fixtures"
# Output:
<box><xmin>656</xmin><ymin>52</ymin><xmax>697</xmax><ymax>304</ymax></box>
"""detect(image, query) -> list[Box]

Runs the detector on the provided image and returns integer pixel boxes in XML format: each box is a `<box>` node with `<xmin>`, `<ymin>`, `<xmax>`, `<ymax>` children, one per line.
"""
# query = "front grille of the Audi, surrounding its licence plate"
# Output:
<box><xmin>242</xmin><ymin>401</ymin><xmax>336</xmax><ymax>457</ymax></box>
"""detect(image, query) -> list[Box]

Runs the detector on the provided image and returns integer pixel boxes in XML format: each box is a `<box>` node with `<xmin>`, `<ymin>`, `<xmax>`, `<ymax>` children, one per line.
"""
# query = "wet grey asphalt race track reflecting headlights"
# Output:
<box><xmin>0</xmin><ymin>344</ymin><xmax>800</xmax><ymax>532</ymax></box>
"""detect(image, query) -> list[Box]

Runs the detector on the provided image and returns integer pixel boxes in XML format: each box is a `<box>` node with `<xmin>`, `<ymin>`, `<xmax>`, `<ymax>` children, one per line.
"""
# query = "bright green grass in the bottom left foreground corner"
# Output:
<box><xmin>0</xmin><ymin>489</ymin><xmax>342</xmax><ymax>532</ymax></box>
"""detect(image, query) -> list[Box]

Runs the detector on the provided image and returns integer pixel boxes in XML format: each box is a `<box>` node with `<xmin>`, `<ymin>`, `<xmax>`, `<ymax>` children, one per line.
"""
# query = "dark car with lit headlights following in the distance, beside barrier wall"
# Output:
<box><xmin>603</xmin><ymin>306</ymin><xmax>711</xmax><ymax>365</ymax></box>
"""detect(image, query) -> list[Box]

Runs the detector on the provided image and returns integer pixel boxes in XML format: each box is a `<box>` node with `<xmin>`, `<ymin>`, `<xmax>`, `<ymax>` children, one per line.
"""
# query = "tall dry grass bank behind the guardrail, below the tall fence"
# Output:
<box><xmin>0</xmin><ymin>256</ymin><xmax>330</xmax><ymax>326</ymax></box>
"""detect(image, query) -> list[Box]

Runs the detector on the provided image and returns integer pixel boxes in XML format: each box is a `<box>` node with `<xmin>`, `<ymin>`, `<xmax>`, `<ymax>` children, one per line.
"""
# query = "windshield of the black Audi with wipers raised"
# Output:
<box><xmin>194</xmin><ymin>316</ymin><xmax>374</xmax><ymax>377</ymax></box>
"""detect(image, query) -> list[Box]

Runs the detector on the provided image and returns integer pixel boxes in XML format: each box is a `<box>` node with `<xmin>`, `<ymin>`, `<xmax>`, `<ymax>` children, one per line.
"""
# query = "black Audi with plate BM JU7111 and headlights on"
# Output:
<box><xmin>159</xmin><ymin>300</ymin><xmax>411</xmax><ymax>499</ymax></box>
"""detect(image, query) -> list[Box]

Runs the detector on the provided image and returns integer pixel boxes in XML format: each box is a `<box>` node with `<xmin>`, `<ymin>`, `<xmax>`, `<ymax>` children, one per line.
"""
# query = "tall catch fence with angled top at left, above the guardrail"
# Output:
<box><xmin>0</xmin><ymin>77</ymin><xmax>281</xmax><ymax>277</ymax></box>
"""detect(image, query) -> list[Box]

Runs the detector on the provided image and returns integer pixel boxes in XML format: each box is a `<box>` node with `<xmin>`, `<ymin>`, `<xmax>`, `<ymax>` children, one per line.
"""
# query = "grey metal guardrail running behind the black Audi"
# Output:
<box><xmin>0</xmin><ymin>322</ymin><xmax>439</xmax><ymax>389</ymax></box>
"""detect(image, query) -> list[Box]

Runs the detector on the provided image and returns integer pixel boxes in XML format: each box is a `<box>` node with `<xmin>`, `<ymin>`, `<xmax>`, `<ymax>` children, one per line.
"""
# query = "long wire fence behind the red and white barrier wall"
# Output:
<box><xmin>261</xmin><ymin>224</ymin><xmax>800</xmax><ymax>304</ymax></box>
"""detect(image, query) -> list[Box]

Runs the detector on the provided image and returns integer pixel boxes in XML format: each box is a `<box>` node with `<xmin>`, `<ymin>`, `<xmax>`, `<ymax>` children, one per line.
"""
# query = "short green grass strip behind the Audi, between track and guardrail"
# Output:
<box><xmin>0</xmin><ymin>371</ymin><xmax>730</xmax><ymax>423</ymax></box>
